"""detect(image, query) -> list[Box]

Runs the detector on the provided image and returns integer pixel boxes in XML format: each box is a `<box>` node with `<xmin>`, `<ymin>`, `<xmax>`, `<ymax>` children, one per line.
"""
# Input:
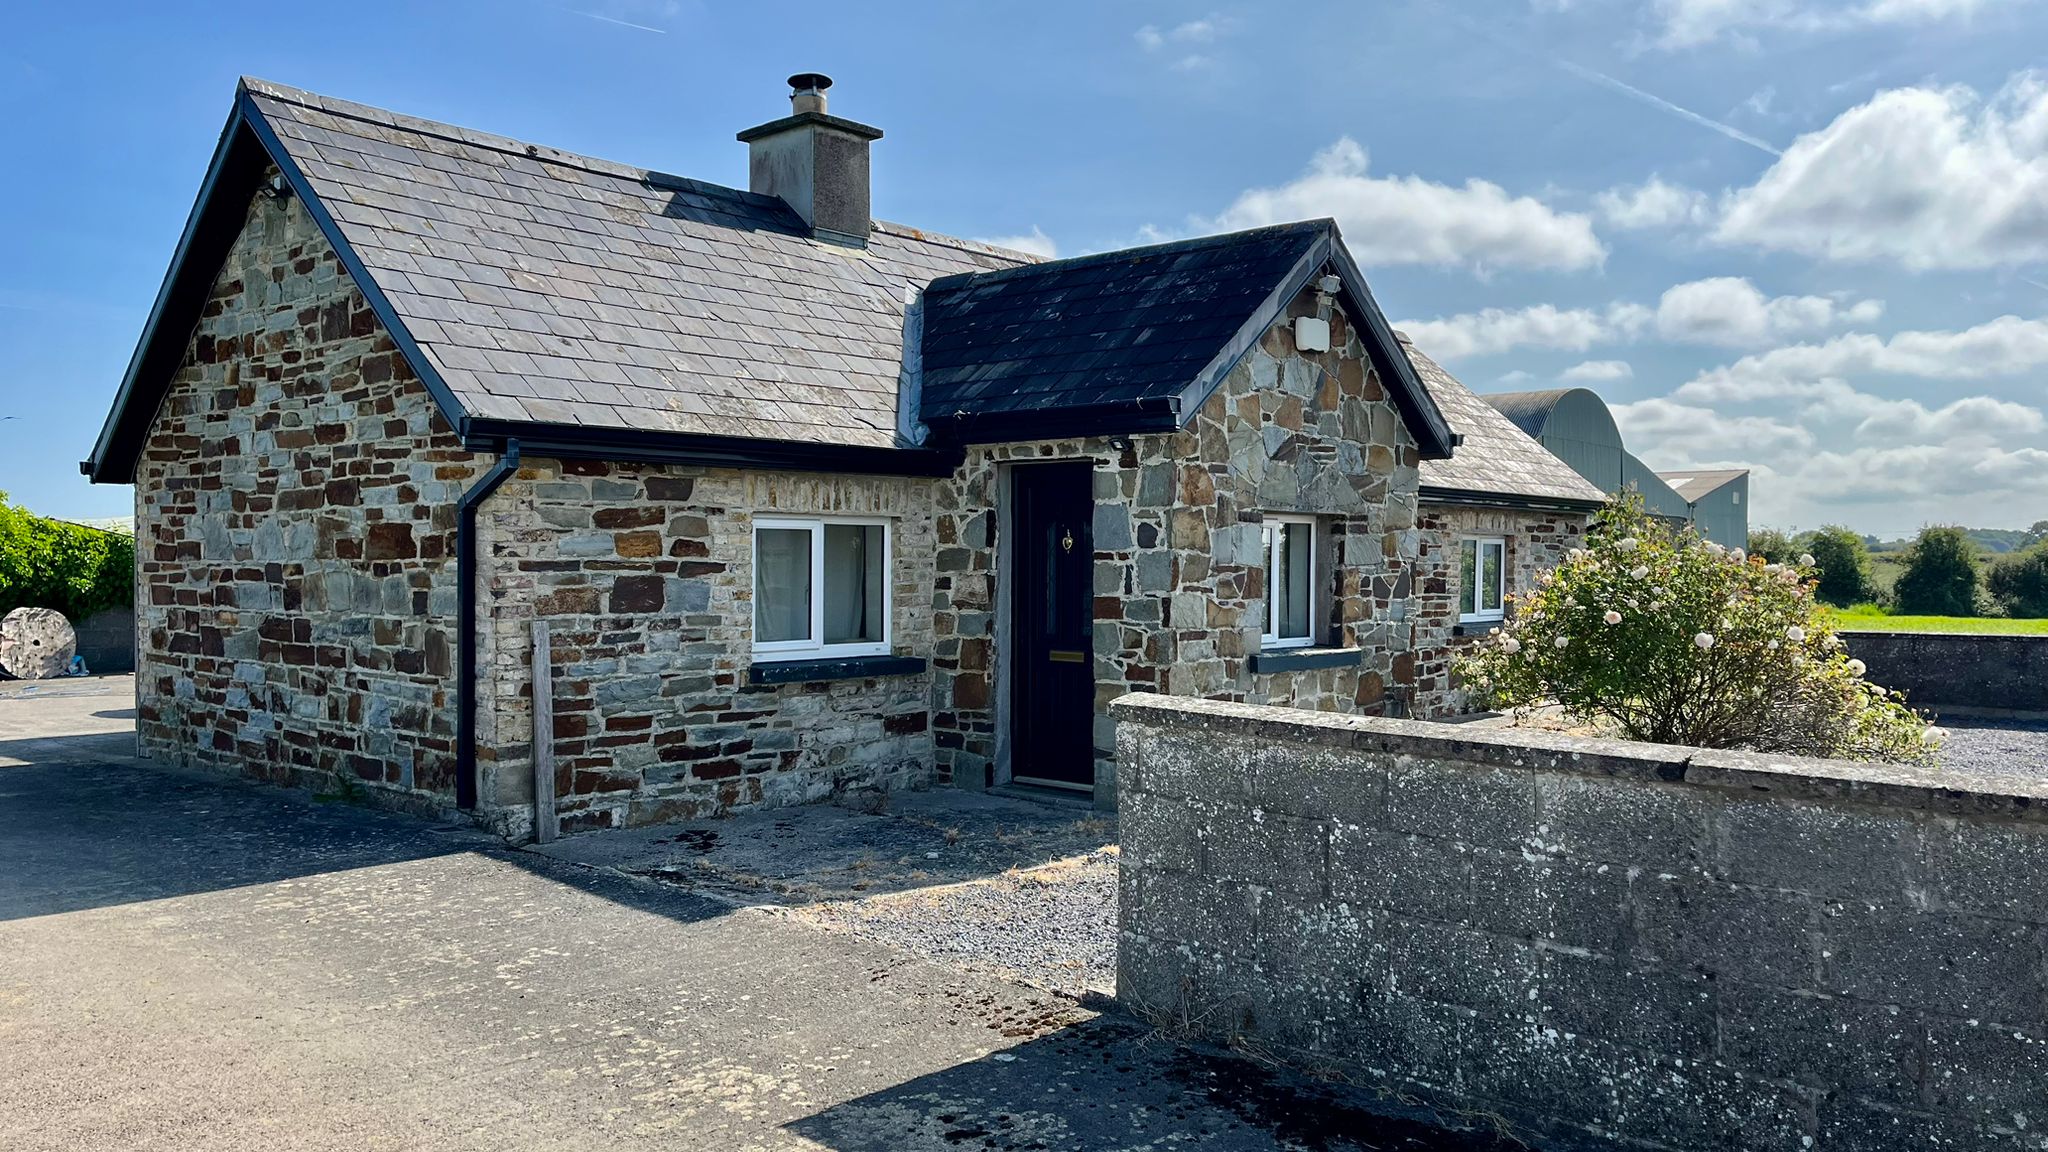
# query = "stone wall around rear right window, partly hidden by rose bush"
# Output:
<box><xmin>1407</xmin><ymin>504</ymin><xmax>1591</xmax><ymax>719</ymax></box>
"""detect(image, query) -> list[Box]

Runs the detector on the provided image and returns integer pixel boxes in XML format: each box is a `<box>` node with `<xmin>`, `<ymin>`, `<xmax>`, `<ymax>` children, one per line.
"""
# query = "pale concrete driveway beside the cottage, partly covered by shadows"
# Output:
<box><xmin>0</xmin><ymin>678</ymin><xmax>1507</xmax><ymax>1152</ymax></box>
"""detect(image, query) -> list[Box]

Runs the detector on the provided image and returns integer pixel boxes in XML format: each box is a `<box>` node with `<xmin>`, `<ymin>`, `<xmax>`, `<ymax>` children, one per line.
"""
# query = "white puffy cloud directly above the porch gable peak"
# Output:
<box><xmin>1198</xmin><ymin>137</ymin><xmax>1608</xmax><ymax>271</ymax></box>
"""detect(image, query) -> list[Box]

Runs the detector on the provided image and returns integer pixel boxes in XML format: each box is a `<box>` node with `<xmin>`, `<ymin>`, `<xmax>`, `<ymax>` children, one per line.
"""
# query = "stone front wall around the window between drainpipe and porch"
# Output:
<box><xmin>477</xmin><ymin>459</ymin><xmax>936</xmax><ymax>834</ymax></box>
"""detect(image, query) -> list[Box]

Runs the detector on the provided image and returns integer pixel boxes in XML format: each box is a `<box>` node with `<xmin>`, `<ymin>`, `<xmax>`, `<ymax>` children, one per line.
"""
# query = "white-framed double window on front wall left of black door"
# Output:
<box><xmin>754</xmin><ymin>517</ymin><xmax>891</xmax><ymax>660</ymax></box>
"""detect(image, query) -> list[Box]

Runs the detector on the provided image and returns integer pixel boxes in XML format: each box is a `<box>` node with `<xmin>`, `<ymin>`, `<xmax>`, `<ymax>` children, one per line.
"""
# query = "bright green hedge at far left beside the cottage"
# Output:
<box><xmin>0</xmin><ymin>492</ymin><xmax>135</xmax><ymax>623</ymax></box>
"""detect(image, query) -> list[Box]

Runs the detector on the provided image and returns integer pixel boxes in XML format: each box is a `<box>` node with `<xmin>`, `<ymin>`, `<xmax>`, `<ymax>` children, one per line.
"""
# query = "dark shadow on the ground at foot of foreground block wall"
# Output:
<box><xmin>786</xmin><ymin>1017</ymin><xmax>1524</xmax><ymax>1152</ymax></box>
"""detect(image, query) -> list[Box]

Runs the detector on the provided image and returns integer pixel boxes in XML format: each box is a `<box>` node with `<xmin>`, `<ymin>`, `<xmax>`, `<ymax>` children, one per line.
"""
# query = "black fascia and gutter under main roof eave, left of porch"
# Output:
<box><xmin>463</xmin><ymin>418</ymin><xmax>965</xmax><ymax>478</ymax></box>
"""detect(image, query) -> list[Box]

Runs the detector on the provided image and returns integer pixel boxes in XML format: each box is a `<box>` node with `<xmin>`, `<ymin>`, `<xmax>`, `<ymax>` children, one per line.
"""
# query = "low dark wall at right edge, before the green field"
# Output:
<box><xmin>1841</xmin><ymin>631</ymin><xmax>2048</xmax><ymax>717</ymax></box>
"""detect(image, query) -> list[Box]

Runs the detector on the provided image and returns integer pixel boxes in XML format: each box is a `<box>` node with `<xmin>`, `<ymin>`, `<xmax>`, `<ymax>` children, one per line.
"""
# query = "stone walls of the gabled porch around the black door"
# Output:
<box><xmin>932</xmin><ymin>289</ymin><xmax>1423</xmax><ymax>787</ymax></box>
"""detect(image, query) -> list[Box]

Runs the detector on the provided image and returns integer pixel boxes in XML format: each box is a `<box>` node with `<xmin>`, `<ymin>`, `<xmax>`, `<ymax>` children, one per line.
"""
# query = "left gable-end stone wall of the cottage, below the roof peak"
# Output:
<box><xmin>135</xmin><ymin>183</ymin><xmax>479</xmax><ymax>806</ymax></box>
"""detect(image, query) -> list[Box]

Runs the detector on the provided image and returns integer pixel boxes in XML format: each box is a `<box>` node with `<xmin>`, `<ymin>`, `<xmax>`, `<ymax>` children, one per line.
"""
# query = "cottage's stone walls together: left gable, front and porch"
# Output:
<box><xmin>135</xmin><ymin>197</ymin><xmax>1546</xmax><ymax>836</ymax></box>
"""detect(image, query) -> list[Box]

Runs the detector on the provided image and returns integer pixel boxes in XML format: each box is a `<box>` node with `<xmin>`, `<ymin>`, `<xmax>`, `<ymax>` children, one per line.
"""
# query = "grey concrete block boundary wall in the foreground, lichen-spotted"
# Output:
<box><xmin>1112</xmin><ymin>695</ymin><xmax>2048</xmax><ymax>1150</ymax></box>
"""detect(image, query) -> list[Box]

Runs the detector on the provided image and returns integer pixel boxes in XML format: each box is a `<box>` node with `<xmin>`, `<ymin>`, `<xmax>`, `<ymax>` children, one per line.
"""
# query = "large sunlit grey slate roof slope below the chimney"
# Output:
<box><xmin>244</xmin><ymin>80</ymin><xmax>1022</xmax><ymax>447</ymax></box>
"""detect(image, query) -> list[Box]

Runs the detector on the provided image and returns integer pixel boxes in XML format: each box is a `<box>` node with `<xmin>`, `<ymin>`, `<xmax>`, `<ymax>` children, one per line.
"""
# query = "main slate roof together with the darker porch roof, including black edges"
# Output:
<box><xmin>84</xmin><ymin>78</ymin><xmax>1452</xmax><ymax>482</ymax></box>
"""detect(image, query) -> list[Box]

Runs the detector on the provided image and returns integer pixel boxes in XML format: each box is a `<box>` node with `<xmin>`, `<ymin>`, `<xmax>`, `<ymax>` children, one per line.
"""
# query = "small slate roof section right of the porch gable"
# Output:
<box><xmin>1397</xmin><ymin>332</ymin><xmax>1606</xmax><ymax>504</ymax></box>
